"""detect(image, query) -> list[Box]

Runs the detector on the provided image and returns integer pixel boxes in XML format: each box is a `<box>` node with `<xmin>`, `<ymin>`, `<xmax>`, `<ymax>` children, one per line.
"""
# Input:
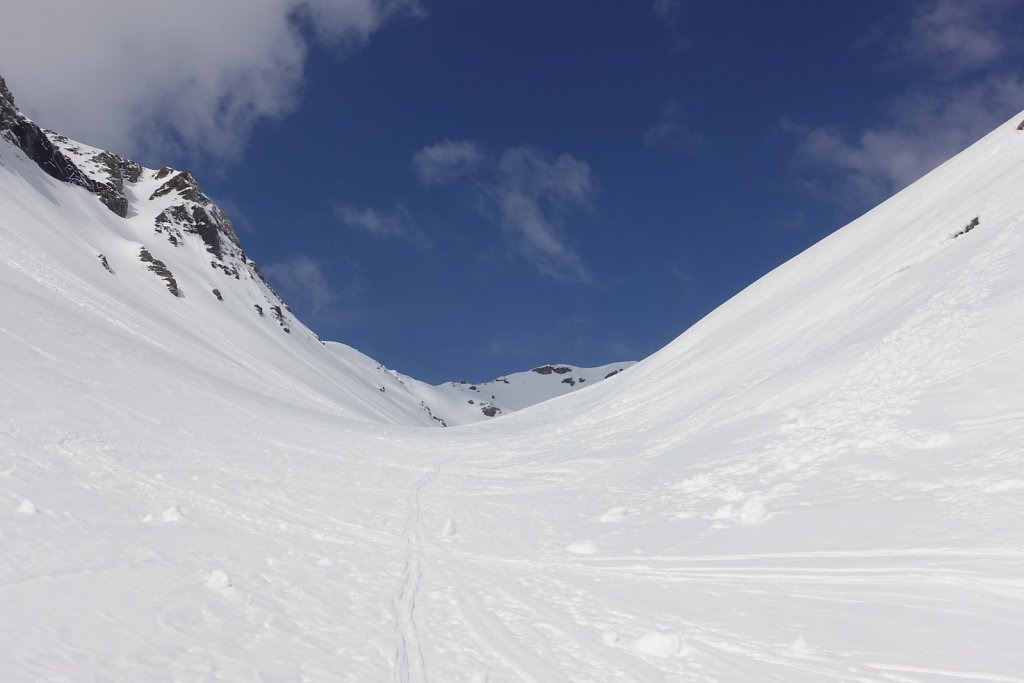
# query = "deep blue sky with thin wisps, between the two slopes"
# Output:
<box><xmin>0</xmin><ymin>0</ymin><xmax>1024</xmax><ymax>382</ymax></box>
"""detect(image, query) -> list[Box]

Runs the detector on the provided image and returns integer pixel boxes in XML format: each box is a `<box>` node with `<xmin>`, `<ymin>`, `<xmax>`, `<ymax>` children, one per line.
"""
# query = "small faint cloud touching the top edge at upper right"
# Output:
<box><xmin>893</xmin><ymin>0</ymin><xmax>1018</xmax><ymax>77</ymax></box>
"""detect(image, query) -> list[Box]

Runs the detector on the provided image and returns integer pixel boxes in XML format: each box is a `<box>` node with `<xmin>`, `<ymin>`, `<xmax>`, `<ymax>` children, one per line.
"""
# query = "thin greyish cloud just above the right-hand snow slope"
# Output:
<box><xmin>787</xmin><ymin>76</ymin><xmax>1024</xmax><ymax>201</ymax></box>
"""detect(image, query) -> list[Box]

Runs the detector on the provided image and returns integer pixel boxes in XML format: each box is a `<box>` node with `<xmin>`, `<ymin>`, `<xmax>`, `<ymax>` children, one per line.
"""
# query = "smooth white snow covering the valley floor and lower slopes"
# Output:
<box><xmin>0</xmin><ymin>117</ymin><xmax>1024</xmax><ymax>683</ymax></box>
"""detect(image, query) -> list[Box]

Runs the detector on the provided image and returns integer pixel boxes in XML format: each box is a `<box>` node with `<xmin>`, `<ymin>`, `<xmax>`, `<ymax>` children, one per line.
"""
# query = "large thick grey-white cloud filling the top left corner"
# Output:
<box><xmin>0</xmin><ymin>0</ymin><xmax>419</xmax><ymax>158</ymax></box>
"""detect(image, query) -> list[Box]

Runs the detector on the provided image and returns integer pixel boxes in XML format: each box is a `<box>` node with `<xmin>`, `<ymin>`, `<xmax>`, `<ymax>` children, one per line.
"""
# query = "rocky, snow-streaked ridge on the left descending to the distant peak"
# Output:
<box><xmin>0</xmin><ymin>78</ymin><xmax>630</xmax><ymax>426</ymax></box>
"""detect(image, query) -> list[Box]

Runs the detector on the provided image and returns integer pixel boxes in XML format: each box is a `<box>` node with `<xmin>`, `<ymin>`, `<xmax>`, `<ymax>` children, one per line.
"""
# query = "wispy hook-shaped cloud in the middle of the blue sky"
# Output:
<box><xmin>413</xmin><ymin>140</ymin><xmax>595</xmax><ymax>282</ymax></box>
